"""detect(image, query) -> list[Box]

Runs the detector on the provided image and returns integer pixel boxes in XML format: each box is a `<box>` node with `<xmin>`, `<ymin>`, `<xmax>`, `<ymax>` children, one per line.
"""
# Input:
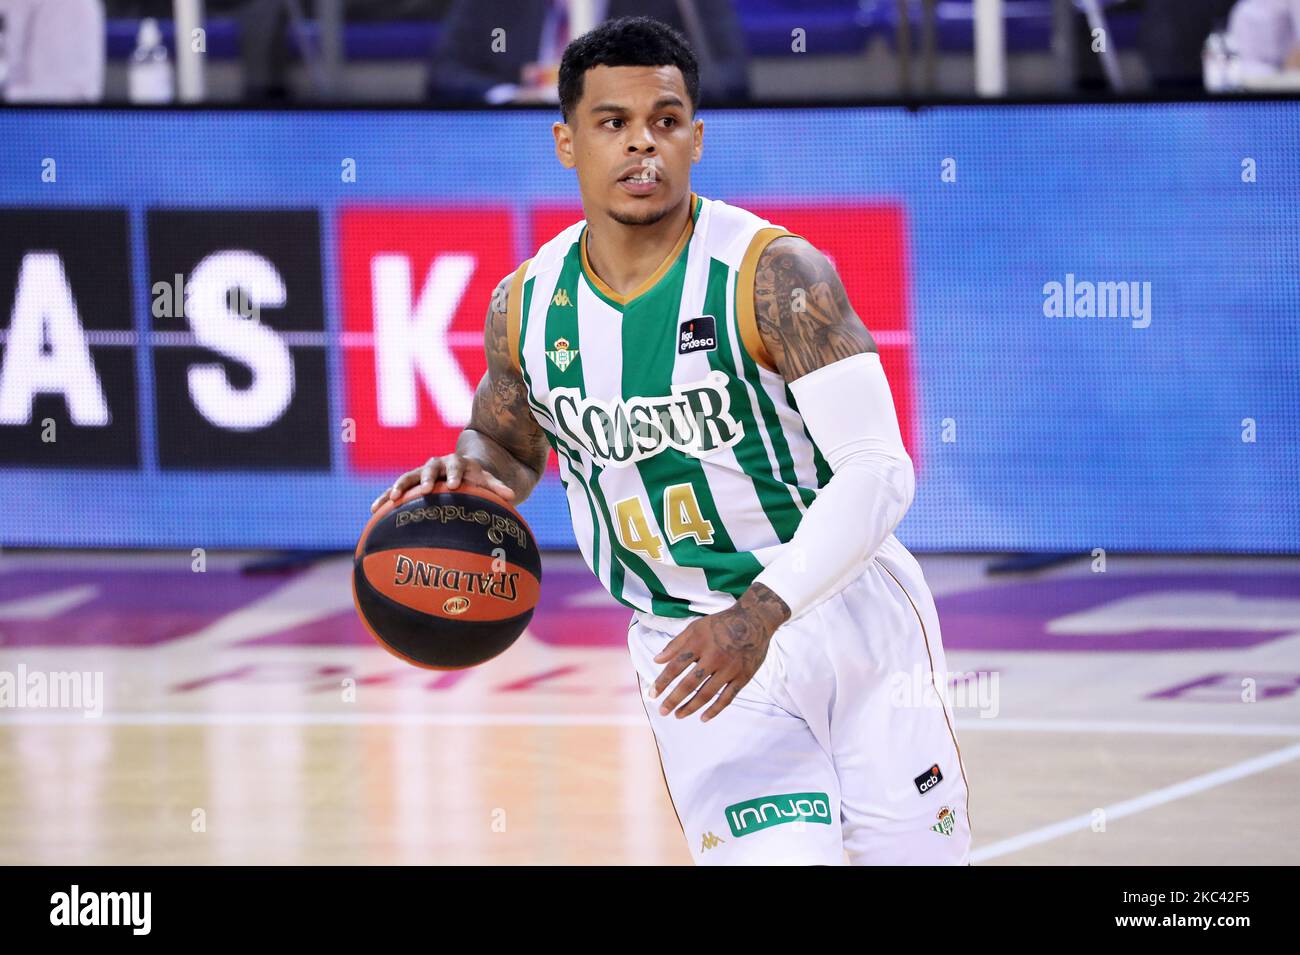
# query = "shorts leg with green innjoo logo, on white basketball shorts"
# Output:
<box><xmin>628</xmin><ymin>624</ymin><xmax>844</xmax><ymax>865</ymax></box>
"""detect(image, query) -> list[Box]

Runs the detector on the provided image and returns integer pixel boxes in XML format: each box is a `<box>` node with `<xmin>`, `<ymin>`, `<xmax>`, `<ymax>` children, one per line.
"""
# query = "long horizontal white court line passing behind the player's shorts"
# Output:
<box><xmin>0</xmin><ymin>708</ymin><xmax>1300</xmax><ymax>738</ymax></box>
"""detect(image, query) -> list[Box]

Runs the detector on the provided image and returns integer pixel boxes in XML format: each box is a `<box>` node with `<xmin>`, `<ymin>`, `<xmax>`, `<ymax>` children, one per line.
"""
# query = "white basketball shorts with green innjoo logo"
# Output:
<box><xmin>628</xmin><ymin>537</ymin><xmax>971</xmax><ymax>865</ymax></box>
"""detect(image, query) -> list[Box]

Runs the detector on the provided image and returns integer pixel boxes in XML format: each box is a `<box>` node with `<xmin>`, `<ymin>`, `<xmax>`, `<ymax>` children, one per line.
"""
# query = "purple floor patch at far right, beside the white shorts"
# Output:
<box><xmin>935</xmin><ymin>574</ymin><xmax>1300</xmax><ymax>651</ymax></box>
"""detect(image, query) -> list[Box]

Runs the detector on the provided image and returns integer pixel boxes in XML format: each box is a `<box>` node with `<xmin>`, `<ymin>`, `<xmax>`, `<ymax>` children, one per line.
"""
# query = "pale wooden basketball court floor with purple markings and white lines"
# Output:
<box><xmin>0</xmin><ymin>552</ymin><xmax>1300</xmax><ymax>865</ymax></box>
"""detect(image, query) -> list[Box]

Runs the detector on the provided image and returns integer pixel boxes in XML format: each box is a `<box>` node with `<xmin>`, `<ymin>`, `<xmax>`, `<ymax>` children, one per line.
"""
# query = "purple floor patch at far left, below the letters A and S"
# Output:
<box><xmin>0</xmin><ymin>566</ymin><xmax>285</xmax><ymax>650</ymax></box>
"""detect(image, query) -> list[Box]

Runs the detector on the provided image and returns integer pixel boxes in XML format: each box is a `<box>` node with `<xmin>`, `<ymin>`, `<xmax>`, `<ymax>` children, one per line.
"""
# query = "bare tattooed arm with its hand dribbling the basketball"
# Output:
<box><xmin>371</xmin><ymin>274</ymin><xmax>550</xmax><ymax>511</ymax></box>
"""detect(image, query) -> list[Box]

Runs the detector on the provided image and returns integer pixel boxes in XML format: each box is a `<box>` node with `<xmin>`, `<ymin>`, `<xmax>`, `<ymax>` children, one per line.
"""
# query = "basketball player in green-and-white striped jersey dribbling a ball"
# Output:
<box><xmin>374</xmin><ymin>17</ymin><xmax>970</xmax><ymax>864</ymax></box>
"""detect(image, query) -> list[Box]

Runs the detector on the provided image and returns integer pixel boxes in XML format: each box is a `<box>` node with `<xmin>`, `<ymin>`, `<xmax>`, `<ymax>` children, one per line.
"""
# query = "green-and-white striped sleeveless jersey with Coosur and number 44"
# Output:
<box><xmin>508</xmin><ymin>194</ymin><xmax>831</xmax><ymax>628</ymax></box>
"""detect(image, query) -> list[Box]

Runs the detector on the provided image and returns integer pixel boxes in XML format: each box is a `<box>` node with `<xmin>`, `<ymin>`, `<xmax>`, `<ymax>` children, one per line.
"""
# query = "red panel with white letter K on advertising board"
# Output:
<box><xmin>338</xmin><ymin>208</ymin><xmax>517</xmax><ymax>472</ymax></box>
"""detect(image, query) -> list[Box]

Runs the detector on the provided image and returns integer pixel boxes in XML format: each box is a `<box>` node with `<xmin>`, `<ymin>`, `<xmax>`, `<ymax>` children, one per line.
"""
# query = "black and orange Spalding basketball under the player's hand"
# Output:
<box><xmin>352</xmin><ymin>481</ymin><xmax>542</xmax><ymax>669</ymax></box>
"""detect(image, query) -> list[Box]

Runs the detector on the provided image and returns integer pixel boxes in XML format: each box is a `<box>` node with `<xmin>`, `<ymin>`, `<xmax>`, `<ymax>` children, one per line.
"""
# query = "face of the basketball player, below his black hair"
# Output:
<box><xmin>555</xmin><ymin>66</ymin><xmax>705</xmax><ymax>225</ymax></box>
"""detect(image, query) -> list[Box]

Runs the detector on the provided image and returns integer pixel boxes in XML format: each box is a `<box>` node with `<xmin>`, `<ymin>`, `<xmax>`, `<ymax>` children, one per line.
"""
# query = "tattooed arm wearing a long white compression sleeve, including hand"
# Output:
<box><xmin>654</xmin><ymin>236</ymin><xmax>913</xmax><ymax>721</ymax></box>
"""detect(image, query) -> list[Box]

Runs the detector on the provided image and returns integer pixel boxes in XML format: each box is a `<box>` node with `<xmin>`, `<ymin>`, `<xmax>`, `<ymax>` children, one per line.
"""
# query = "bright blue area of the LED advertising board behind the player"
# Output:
<box><xmin>0</xmin><ymin>101</ymin><xmax>1300</xmax><ymax>552</ymax></box>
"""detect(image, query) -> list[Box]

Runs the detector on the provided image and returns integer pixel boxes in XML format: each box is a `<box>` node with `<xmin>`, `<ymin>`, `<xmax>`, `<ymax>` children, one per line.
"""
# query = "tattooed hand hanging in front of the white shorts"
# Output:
<box><xmin>651</xmin><ymin>587</ymin><xmax>789</xmax><ymax>722</ymax></box>
